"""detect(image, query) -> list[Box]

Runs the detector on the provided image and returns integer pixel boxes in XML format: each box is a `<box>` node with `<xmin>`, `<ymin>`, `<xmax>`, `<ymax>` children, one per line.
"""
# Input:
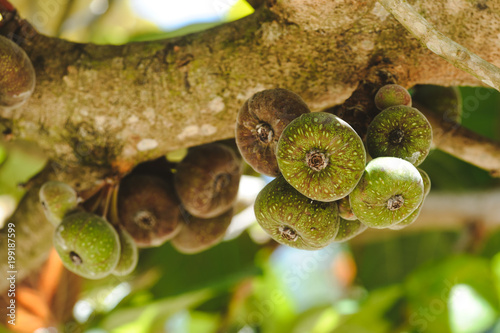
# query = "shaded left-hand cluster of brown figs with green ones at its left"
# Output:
<box><xmin>39</xmin><ymin>143</ymin><xmax>243</xmax><ymax>279</ymax></box>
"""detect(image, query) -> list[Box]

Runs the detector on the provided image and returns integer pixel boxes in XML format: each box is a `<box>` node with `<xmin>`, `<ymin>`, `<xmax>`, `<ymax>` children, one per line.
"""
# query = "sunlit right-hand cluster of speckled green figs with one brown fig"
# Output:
<box><xmin>236</xmin><ymin>84</ymin><xmax>432</xmax><ymax>250</ymax></box>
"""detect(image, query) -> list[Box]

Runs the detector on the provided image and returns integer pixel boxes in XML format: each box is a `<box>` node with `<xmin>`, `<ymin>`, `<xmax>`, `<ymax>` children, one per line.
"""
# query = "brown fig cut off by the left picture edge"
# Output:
<box><xmin>0</xmin><ymin>36</ymin><xmax>35</xmax><ymax>108</ymax></box>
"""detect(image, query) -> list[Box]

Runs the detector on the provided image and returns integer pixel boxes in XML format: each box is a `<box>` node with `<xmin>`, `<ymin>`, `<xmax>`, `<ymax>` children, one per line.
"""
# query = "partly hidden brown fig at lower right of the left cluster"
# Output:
<box><xmin>170</xmin><ymin>208</ymin><xmax>233</xmax><ymax>254</ymax></box>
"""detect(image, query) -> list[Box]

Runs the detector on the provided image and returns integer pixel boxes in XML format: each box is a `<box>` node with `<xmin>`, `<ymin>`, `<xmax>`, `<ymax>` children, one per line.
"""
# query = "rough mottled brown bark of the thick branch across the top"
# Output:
<box><xmin>0</xmin><ymin>0</ymin><xmax>500</xmax><ymax>290</ymax></box>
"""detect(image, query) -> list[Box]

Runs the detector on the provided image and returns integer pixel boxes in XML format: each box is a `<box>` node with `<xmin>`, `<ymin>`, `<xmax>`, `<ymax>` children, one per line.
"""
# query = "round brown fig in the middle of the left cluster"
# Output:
<box><xmin>118</xmin><ymin>174</ymin><xmax>182</xmax><ymax>248</ymax></box>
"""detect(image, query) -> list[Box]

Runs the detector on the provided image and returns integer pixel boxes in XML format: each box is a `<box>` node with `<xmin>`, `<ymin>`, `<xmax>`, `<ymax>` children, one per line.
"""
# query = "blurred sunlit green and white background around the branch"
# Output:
<box><xmin>0</xmin><ymin>0</ymin><xmax>500</xmax><ymax>333</ymax></box>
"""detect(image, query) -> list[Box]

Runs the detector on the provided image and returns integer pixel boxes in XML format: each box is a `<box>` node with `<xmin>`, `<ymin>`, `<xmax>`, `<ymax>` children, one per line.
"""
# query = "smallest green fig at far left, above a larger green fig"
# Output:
<box><xmin>39</xmin><ymin>181</ymin><xmax>78</xmax><ymax>227</ymax></box>
